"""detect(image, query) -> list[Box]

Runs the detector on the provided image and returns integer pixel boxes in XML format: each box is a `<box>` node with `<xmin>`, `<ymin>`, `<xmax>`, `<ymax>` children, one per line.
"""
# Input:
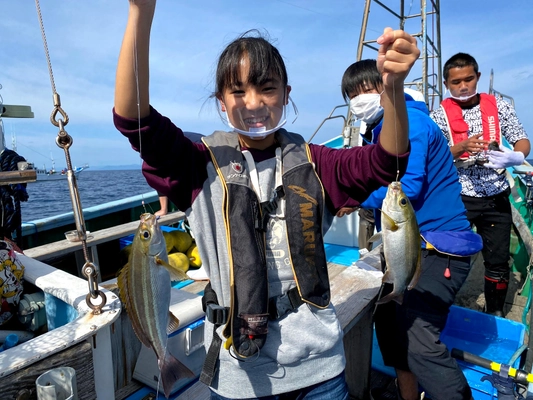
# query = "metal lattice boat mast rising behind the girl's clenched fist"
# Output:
<box><xmin>357</xmin><ymin>0</ymin><xmax>443</xmax><ymax>110</ymax></box>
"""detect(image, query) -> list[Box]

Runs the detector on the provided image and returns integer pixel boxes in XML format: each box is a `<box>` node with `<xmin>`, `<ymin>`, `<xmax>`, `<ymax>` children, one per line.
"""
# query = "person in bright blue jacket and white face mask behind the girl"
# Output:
<box><xmin>341</xmin><ymin>60</ymin><xmax>481</xmax><ymax>400</ymax></box>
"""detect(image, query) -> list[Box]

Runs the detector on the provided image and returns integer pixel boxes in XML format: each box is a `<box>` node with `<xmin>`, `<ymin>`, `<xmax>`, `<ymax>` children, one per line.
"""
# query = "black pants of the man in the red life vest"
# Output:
<box><xmin>461</xmin><ymin>190</ymin><xmax>513</xmax><ymax>280</ymax></box>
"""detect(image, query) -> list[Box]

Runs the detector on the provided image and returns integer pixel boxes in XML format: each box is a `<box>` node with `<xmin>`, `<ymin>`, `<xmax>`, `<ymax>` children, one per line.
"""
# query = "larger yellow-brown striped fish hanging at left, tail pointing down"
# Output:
<box><xmin>117</xmin><ymin>213</ymin><xmax>194</xmax><ymax>398</ymax></box>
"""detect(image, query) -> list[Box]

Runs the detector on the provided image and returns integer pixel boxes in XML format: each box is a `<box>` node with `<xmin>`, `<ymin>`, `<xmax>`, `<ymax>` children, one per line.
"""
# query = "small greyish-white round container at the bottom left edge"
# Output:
<box><xmin>35</xmin><ymin>367</ymin><xmax>78</xmax><ymax>400</ymax></box>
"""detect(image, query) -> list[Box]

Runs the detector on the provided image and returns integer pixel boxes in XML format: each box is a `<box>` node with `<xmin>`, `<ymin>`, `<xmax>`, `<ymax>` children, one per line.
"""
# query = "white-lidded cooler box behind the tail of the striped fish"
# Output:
<box><xmin>133</xmin><ymin>288</ymin><xmax>205</xmax><ymax>393</ymax></box>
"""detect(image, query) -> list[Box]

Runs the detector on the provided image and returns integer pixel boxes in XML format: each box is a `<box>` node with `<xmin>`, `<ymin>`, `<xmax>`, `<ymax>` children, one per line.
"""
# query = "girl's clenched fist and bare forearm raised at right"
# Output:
<box><xmin>377</xmin><ymin>28</ymin><xmax>420</xmax><ymax>154</ymax></box>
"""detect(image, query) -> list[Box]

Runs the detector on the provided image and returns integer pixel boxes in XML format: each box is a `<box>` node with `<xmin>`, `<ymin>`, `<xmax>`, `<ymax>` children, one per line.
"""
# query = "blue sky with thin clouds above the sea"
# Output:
<box><xmin>0</xmin><ymin>0</ymin><xmax>533</xmax><ymax>167</ymax></box>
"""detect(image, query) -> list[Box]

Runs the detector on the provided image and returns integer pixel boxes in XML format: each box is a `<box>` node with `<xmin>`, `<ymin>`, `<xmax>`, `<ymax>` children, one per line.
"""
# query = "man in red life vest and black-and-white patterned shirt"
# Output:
<box><xmin>431</xmin><ymin>53</ymin><xmax>530</xmax><ymax>316</ymax></box>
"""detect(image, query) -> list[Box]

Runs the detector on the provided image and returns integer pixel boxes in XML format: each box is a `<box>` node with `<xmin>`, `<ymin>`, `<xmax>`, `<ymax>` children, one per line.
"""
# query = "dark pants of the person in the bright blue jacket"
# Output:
<box><xmin>374</xmin><ymin>250</ymin><xmax>472</xmax><ymax>400</ymax></box>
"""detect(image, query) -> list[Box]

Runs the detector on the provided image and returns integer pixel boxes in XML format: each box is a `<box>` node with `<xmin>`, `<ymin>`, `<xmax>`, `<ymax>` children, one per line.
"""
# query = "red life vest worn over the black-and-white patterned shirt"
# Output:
<box><xmin>440</xmin><ymin>93</ymin><xmax>501</xmax><ymax>159</ymax></box>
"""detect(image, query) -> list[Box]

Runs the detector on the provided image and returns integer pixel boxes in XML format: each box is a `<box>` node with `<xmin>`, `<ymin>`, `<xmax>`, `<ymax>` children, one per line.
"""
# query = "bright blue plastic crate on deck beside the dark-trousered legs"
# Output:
<box><xmin>372</xmin><ymin>306</ymin><xmax>526</xmax><ymax>400</ymax></box>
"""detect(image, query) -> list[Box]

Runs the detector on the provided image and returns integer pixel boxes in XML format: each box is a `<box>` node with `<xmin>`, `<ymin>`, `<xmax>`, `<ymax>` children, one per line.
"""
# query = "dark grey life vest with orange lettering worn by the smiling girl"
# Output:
<box><xmin>202</xmin><ymin>129</ymin><xmax>331</xmax><ymax>358</ymax></box>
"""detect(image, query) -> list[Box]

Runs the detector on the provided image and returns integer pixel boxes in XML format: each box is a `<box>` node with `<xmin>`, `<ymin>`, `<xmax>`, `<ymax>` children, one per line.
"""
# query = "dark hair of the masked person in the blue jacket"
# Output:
<box><xmin>341</xmin><ymin>60</ymin><xmax>383</xmax><ymax>101</ymax></box>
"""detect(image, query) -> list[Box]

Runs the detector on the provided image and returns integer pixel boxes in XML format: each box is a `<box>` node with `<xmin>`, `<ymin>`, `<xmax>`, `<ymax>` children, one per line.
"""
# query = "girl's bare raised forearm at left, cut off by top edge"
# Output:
<box><xmin>115</xmin><ymin>0</ymin><xmax>156</xmax><ymax>118</ymax></box>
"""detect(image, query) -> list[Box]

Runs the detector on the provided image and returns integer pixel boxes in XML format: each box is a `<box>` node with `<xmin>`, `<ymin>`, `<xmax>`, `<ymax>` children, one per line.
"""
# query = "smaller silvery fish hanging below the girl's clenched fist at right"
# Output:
<box><xmin>377</xmin><ymin>182</ymin><xmax>421</xmax><ymax>304</ymax></box>
